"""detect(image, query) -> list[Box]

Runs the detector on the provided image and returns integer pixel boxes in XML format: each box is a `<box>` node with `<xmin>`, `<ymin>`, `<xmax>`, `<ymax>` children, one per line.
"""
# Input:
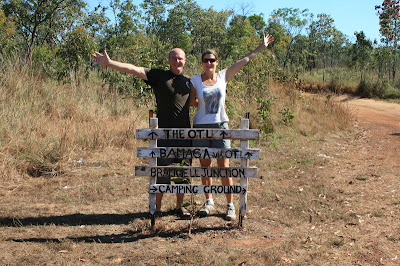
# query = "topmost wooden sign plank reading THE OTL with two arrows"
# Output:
<box><xmin>136</xmin><ymin>128</ymin><xmax>260</xmax><ymax>140</ymax></box>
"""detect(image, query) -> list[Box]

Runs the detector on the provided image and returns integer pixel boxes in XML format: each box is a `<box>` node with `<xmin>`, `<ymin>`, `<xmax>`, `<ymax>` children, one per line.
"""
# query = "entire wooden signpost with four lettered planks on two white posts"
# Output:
<box><xmin>135</xmin><ymin>116</ymin><xmax>260</xmax><ymax>226</ymax></box>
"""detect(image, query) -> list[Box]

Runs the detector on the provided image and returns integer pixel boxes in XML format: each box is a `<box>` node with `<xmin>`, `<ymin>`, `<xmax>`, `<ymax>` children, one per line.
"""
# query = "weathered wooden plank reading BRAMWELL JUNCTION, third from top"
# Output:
<box><xmin>135</xmin><ymin>166</ymin><xmax>257</xmax><ymax>178</ymax></box>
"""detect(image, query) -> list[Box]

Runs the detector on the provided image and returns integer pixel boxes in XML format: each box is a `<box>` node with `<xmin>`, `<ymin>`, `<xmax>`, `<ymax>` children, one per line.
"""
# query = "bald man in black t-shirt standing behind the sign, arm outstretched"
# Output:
<box><xmin>92</xmin><ymin>48</ymin><xmax>191</xmax><ymax>217</ymax></box>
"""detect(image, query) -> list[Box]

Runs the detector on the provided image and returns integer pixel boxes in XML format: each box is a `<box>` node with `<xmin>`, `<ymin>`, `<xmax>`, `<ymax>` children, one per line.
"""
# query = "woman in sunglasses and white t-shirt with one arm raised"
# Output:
<box><xmin>190</xmin><ymin>34</ymin><xmax>274</xmax><ymax>221</ymax></box>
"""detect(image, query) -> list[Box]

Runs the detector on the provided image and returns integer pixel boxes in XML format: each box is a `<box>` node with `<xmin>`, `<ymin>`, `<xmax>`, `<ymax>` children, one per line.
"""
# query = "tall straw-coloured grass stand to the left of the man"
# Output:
<box><xmin>0</xmin><ymin>58</ymin><xmax>145</xmax><ymax>177</ymax></box>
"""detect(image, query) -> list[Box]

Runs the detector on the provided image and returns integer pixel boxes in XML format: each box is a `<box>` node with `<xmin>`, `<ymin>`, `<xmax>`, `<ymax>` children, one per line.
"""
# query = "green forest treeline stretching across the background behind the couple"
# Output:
<box><xmin>0</xmin><ymin>0</ymin><xmax>400</xmax><ymax>98</ymax></box>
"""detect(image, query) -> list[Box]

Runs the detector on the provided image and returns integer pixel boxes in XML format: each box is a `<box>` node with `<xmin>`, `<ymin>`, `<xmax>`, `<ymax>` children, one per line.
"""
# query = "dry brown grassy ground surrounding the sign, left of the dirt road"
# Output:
<box><xmin>0</xmin><ymin>61</ymin><xmax>394</xmax><ymax>265</ymax></box>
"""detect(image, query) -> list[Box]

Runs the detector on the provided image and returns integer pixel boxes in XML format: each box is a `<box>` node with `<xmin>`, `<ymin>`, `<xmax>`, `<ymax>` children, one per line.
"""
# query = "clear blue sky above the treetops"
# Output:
<box><xmin>87</xmin><ymin>0</ymin><xmax>383</xmax><ymax>42</ymax></box>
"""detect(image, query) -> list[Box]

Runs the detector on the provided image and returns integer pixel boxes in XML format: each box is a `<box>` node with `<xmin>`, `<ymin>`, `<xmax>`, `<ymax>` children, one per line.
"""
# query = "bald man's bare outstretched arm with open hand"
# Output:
<box><xmin>92</xmin><ymin>50</ymin><xmax>147</xmax><ymax>80</ymax></box>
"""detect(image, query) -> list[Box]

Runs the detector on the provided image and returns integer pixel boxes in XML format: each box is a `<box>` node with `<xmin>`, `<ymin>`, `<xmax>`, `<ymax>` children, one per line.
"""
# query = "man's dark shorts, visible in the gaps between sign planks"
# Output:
<box><xmin>156</xmin><ymin>139</ymin><xmax>192</xmax><ymax>184</ymax></box>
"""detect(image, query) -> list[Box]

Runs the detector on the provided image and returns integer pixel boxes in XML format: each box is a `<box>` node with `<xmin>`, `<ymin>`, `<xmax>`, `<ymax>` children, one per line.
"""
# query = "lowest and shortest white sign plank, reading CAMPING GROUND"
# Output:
<box><xmin>149</xmin><ymin>184</ymin><xmax>247</xmax><ymax>194</ymax></box>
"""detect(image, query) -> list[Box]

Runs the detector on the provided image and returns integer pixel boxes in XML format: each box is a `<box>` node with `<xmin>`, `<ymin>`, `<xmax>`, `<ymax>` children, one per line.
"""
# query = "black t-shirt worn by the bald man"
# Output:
<box><xmin>145</xmin><ymin>69</ymin><xmax>190</xmax><ymax>128</ymax></box>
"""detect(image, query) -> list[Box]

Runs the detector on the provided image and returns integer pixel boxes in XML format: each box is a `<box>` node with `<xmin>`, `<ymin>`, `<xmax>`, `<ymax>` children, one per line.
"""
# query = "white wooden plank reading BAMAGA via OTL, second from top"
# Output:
<box><xmin>137</xmin><ymin>147</ymin><xmax>260</xmax><ymax>159</ymax></box>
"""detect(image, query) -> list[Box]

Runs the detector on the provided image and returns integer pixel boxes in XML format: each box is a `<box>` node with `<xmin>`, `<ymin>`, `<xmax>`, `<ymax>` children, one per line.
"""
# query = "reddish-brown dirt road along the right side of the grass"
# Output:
<box><xmin>324</xmin><ymin>96</ymin><xmax>400</xmax><ymax>265</ymax></box>
